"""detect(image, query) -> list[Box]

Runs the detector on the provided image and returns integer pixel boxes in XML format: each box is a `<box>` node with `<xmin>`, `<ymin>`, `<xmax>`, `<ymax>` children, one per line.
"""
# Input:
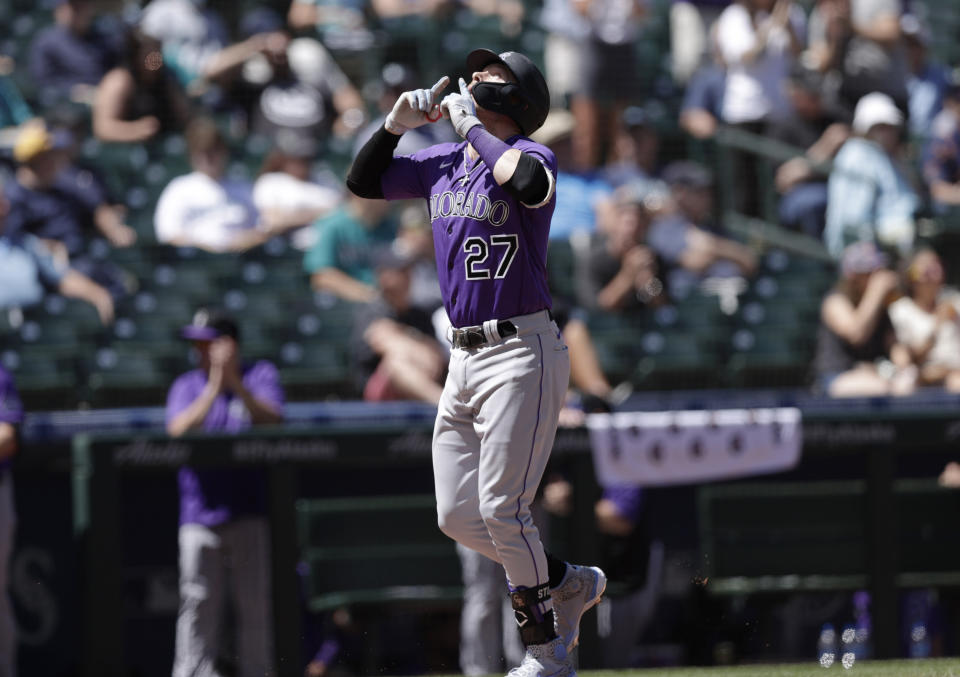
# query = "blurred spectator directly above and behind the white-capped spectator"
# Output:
<box><xmin>809</xmin><ymin>0</ymin><xmax>907</xmax><ymax>111</ymax></box>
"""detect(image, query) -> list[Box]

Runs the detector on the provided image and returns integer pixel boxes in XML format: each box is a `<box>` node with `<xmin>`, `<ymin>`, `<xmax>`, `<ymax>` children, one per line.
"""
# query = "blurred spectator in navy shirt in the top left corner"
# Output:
<box><xmin>30</xmin><ymin>0</ymin><xmax>120</xmax><ymax>107</ymax></box>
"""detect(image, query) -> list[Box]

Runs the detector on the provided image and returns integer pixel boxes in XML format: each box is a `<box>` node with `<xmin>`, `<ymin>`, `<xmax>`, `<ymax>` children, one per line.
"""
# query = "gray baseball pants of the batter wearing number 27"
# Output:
<box><xmin>433</xmin><ymin>310</ymin><xmax>570</xmax><ymax>588</ymax></box>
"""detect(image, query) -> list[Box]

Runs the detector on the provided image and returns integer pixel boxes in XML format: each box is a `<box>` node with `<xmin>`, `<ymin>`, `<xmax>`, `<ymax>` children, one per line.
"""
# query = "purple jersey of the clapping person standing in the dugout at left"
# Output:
<box><xmin>166</xmin><ymin>360</ymin><xmax>284</xmax><ymax>527</ymax></box>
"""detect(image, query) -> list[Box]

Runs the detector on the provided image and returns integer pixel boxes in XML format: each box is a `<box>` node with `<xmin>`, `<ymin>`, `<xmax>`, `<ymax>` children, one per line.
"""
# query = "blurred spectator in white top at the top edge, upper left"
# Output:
<box><xmin>139</xmin><ymin>0</ymin><xmax>230</xmax><ymax>87</ymax></box>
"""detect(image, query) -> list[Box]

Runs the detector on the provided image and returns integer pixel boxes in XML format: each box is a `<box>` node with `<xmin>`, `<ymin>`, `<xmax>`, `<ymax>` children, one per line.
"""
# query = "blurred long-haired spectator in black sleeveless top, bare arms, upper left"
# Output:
<box><xmin>92</xmin><ymin>29</ymin><xmax>190</xmax><ymax>143</ymax></box>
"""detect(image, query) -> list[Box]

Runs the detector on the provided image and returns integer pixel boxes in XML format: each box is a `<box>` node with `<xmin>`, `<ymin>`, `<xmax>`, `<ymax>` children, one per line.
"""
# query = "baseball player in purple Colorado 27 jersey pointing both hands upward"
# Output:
<box><xmin>347</xmin><ymin>49</ymin><xmax>606</xmax><ymax>677</ymax></box>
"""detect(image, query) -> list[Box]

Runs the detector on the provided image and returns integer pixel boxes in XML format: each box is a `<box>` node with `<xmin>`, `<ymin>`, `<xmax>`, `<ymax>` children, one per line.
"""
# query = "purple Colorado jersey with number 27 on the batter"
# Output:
<box><xmin>381</xmin><ymin>136</ymin><xmax>557</xmax><ymax>327</ymax></box>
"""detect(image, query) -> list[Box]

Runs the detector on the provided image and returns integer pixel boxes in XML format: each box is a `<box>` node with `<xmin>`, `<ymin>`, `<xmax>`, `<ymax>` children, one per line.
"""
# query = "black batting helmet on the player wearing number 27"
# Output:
<box><xmin>467</xmin><ymin>49</ymin><xmax>550</xmax><ymax>136</ymax></box>
